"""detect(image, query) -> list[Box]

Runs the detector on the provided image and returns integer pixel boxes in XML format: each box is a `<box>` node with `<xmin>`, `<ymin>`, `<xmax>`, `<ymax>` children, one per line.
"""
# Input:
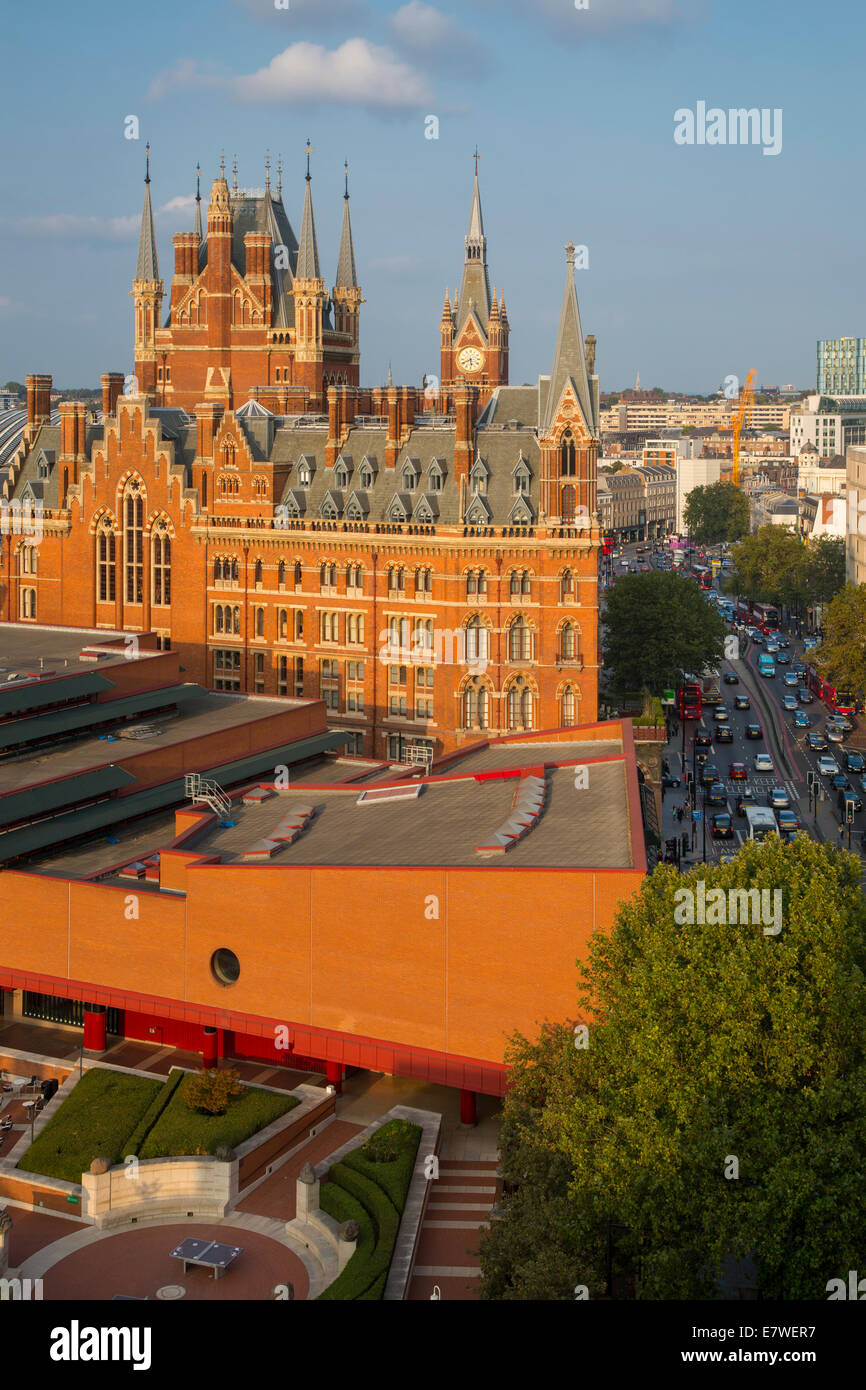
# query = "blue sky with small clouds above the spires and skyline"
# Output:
<box><xmin>0</xmin><ymin>0</ymin><xmax>866</xmax><ymax>393</ymax></box>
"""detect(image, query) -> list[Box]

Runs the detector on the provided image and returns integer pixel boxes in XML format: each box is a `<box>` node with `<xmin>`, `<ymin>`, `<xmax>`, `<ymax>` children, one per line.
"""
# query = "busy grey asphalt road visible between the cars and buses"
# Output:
<box><xmin>613</xmin><ymin>545</ymin><xmax>866</xmax><ymax>878</ymax></box>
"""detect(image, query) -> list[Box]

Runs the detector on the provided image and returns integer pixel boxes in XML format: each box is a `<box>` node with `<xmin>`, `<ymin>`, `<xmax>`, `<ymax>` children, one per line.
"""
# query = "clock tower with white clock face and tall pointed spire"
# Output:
<box><xmin>439</xmin><ymin>152</ymin><xmax>509</xmax><ymax>406</ymax></box>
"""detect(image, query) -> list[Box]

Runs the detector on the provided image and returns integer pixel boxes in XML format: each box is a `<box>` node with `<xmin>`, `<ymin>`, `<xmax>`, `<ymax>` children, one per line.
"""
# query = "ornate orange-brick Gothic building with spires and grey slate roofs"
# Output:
<box><xmin>0</xmin><ymin>165</ymin><xmax>601</xmax><ymax>760</ymax></box>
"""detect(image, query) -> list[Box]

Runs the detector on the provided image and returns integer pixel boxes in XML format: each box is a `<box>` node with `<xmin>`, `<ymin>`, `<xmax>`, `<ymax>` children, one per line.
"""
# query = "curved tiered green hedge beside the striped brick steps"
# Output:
<box><xmin>318</xmin><ymin>1120</ymin><xmax>421</xmax><ymax>1301</ymax></box>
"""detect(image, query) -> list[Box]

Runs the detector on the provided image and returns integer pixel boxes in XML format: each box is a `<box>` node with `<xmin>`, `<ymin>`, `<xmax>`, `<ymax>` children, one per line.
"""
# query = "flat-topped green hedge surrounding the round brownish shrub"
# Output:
<box><xmin>139</xmin><ymin>1073</ymin><xmax>300</xmax><ymax>1158</ymax></box>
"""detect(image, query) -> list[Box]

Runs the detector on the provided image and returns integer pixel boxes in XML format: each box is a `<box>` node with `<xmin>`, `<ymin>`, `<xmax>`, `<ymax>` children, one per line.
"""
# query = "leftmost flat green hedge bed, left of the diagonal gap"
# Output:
<box><xmin>18</xmin><ymin>1066</ymin><xmax>163</xmax><ymax>1183</ymax></box>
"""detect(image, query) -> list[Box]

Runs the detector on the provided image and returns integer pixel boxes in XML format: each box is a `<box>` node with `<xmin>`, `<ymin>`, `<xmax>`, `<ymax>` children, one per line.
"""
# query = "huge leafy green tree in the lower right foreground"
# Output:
<box><xmin>481</xmin><ymin>835</ymin><xmax>866</xmax><ymax>1300</ymax></box>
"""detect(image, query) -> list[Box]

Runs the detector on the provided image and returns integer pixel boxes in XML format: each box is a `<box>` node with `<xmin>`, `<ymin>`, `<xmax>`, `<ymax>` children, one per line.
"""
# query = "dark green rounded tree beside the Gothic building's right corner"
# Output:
<box><xmin>603</xmin><ymin>570</ymin><xmax>726</xmax><ymax>695</ymax></box>
